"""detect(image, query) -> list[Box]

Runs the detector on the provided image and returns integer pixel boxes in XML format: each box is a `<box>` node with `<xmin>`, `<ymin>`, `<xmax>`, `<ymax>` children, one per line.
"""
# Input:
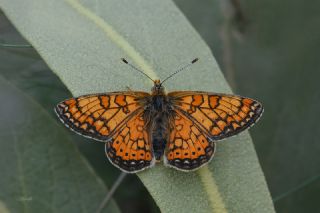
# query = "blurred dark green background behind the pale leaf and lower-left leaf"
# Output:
<box><xmin>0</xmin><ymin>0</ymin><xmax>320</xmax><ymax>212</ymax></box>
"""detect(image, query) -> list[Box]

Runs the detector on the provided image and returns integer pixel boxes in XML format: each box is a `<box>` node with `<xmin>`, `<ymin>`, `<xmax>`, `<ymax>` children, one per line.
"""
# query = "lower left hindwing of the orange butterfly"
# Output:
<box><xmin>106</xmin><ymin>112</ymin><xmax>155</xmax><ymax>173</ymax></box>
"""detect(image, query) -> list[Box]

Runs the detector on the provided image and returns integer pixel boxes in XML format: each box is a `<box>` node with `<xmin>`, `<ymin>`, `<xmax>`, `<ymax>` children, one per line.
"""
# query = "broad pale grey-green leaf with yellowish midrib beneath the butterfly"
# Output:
<box><xmin>0</xmin><ymin>0</ymin><xmax>274</xmax><ymax>212</ymax></box>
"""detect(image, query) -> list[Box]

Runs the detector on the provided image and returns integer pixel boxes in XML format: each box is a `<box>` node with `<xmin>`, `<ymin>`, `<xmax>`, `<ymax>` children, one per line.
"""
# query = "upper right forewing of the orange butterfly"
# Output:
<box><xmin>168</xmin><ymin>92</ymin><xmax>263</xmax><ymax>140</ymax></box>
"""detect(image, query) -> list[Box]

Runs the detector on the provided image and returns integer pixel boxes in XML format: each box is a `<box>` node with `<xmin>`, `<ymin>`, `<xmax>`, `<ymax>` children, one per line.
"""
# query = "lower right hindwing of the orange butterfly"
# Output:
<box><xmin>164</xmin><ymin>110</ymin><xmax>215</xmax><ymax>171</ymax></box>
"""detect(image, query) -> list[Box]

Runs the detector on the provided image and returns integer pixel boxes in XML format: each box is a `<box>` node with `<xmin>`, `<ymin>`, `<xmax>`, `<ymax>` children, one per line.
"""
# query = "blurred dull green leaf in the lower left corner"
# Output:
<box><xmin>0</xmin><ymin>77</ymin><xmax>118</xmax><ymax>212</ymax></box>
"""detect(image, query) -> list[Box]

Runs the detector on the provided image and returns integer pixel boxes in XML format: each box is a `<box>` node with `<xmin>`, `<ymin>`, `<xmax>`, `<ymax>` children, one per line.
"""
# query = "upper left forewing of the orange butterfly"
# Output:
<box><xmin>55</xmin><ymin>92</ymin><xmax>149</xmax><ymax>141</ymax></box>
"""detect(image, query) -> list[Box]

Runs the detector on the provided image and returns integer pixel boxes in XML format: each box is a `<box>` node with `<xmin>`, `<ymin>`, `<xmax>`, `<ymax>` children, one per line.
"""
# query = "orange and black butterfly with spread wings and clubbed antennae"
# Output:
<box><xmin>55</xmin><ymin>58</ymin><xmax>263</xmax><ymax>173</ymax></box>
